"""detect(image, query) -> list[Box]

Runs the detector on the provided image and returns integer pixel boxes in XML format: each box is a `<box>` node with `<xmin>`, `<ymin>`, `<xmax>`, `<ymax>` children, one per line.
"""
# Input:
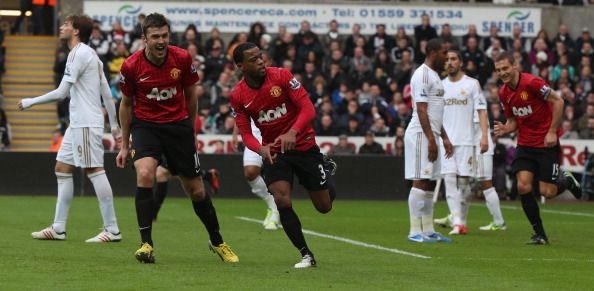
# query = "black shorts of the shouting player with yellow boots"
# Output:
<box><xmin>130</xmin><ymin>119</ymin><xmax>200</xmax><ymax>178</ymax></box>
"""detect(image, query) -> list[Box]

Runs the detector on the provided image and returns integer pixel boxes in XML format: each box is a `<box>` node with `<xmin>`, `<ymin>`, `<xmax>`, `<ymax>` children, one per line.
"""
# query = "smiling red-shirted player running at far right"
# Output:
<box><xmin>494</xmin><ymin>52</ymin><xmax>581</xmax><ymax>245</ymax></box>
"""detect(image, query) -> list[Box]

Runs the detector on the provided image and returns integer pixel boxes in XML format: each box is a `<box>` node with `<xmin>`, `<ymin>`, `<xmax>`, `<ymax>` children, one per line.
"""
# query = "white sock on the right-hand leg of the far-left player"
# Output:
<box><xmin>87</xmin><ymin>171</ymin><xmax>120</xmax><ymax>234</ymax></box>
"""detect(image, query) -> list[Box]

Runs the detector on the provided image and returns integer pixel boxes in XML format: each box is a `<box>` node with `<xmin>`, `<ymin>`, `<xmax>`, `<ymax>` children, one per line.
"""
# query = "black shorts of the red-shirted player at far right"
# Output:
<box><xmin>512</xmin><ymin>144</ymin><xmax>561</xmax><ymax>183</ymax></box>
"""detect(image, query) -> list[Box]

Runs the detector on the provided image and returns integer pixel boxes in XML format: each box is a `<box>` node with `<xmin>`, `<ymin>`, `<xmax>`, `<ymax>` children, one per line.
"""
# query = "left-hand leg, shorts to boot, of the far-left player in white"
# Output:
<box><xmin>31</xmin><ymin>128</ymin><xmax>75</xmax><ymax>240</ymax></box>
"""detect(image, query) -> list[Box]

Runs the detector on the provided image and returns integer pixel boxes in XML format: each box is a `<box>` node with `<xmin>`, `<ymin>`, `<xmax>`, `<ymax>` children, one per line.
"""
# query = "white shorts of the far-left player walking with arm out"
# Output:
<box><xmin>56</xmin><ymin>127</ymin><xmax>104</xmax><ymax>168</ymax></box>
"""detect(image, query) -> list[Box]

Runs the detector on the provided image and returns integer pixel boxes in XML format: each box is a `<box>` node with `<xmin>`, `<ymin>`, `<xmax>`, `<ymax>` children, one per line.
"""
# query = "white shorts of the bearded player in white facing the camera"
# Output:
<box><xmin>439</xmin><ymin>143</ymin><xmax>474</xmax><ymax>177</ymax></box>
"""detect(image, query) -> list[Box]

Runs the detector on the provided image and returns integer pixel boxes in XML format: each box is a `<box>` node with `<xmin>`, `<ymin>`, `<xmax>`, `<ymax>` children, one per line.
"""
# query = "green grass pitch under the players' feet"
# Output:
<box><xmin>0</xmin><ymin>196</ymin><xmax>594</xmax><ymax>290</ymax></box>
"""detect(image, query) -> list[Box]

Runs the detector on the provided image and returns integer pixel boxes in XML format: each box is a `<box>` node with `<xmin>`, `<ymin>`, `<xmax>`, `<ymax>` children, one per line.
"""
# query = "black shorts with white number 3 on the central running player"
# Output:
<box><xmin>262</xmin><ymin>146</ymin><xmax>329</xmax><ymax>191</ymax></box>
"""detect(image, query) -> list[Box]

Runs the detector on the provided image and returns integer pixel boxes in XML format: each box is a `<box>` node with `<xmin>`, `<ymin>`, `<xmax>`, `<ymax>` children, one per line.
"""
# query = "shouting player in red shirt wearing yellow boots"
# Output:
<box><xmin>116</xmin><ymin>13</ymin><xmax>239</xmax><ymax>263</ymax></box>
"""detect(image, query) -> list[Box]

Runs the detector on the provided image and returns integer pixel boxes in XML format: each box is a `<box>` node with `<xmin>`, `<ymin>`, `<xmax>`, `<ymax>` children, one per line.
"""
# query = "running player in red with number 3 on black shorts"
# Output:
<box><xmin>231</xmin><ymin>43</ymin><xmax>335</xmax><ymax>268</ymax></box>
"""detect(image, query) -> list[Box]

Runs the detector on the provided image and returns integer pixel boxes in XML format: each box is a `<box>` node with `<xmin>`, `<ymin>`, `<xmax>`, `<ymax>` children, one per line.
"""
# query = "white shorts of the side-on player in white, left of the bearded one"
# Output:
<box><xmin>404</xmin><ymin>131</ymin><xmax>441</xmax><ymax>180</ymax></box>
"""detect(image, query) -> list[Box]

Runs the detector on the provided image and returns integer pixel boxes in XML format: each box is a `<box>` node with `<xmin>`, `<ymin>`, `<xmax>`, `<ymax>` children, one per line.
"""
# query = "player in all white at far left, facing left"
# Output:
<box><xmin>18</xmin><ymin>15</ymin><xmax>122</xmax><ymax>243</ymax></box>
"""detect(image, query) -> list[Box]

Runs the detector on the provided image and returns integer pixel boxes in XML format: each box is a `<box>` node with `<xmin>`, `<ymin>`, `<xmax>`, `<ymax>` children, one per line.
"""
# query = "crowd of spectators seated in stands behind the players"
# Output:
<box><xmin>3</xmin><ymin>15</ymin><xmax>594</xmax><ymax>156</ymax></box>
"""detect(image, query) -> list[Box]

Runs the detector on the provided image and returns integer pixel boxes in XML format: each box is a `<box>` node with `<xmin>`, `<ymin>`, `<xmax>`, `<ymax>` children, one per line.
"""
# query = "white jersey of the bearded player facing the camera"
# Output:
<box><xmin>443</xmin><ymin>75</ymin><xmax>486</xmax><ymax>146</ymax></box>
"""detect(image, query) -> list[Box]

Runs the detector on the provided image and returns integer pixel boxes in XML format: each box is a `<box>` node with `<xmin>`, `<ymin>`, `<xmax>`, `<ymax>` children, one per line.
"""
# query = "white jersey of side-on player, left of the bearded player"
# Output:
<box><xmin>406</xmin><ymin>64</ymin><xmax>444</xmax><ymax>135</ymax></box>
